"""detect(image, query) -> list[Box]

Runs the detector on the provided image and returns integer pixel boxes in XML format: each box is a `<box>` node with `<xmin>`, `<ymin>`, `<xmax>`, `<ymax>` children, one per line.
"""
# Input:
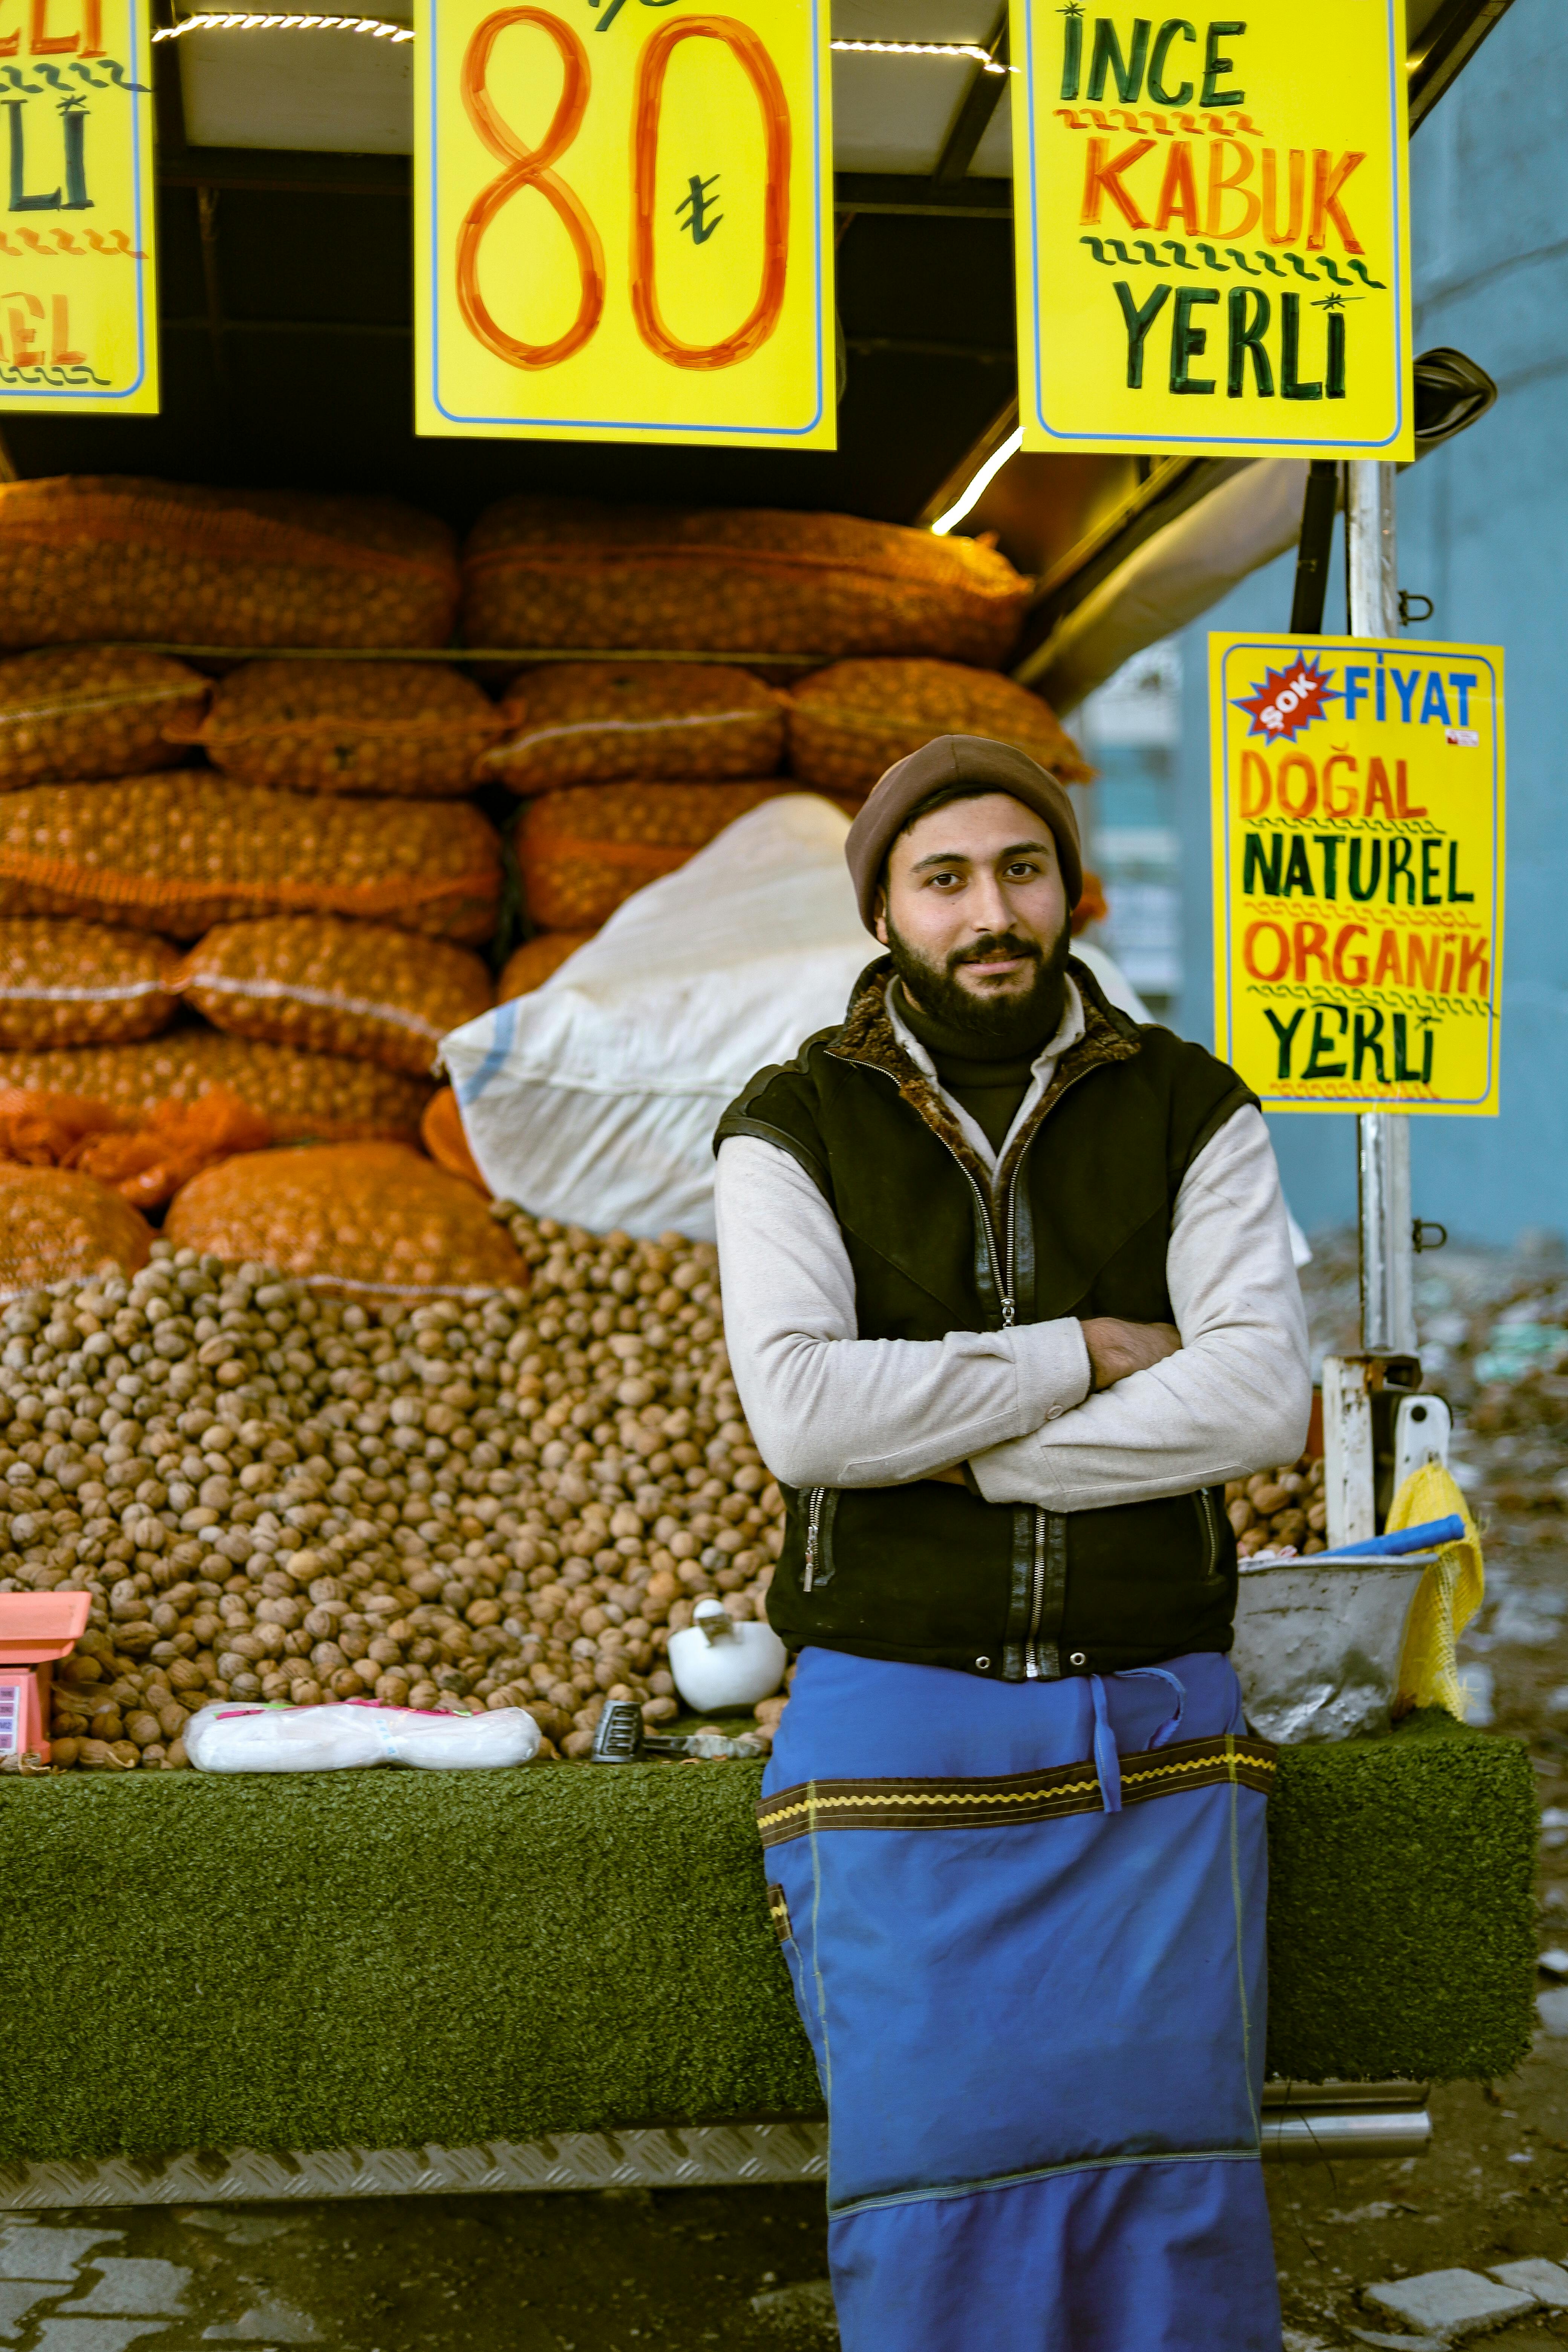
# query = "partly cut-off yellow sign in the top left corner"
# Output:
<box><xmin>0</xmin><ymin>0</ymin><xmax>158</xmax><ymax>416</ymax></box>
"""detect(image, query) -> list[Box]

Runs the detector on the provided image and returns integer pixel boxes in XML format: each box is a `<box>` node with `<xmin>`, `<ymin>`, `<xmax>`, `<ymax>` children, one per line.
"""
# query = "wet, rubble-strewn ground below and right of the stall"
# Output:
<box><xmin>0</xmin><ymin>1244</ymin><xmax>1568</xmax><ymax>2352</ymax></box>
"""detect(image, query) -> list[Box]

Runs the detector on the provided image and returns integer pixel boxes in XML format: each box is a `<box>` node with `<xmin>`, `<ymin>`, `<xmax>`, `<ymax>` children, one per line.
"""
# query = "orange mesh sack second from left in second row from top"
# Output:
<box><xmin>186</xmin><ymin>661</ymin><xmax>503</xmax><ymax>800</ymax></box>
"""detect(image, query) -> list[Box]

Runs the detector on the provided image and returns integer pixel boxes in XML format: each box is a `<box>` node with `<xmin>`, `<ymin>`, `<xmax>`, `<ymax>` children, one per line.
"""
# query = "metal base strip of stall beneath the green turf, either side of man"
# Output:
<box><xmin>0</xmin><ymin>2081</ymin><xmax>1432</xmax><ymax>2211</ymax></box>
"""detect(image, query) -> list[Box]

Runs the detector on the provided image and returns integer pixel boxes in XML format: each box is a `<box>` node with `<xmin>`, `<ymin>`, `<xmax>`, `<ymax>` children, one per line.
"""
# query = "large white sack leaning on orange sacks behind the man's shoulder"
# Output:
<box><xmin>442</xmin><ymin>793</ymin><xmax>877</xmax><ymax>1242</ymax></box>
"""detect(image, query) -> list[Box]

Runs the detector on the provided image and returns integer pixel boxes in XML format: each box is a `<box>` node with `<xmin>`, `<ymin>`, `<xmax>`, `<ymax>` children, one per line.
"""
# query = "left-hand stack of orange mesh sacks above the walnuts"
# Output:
<box><xmin>0</xmin><ymin>478</ymin><xmax>501</xmax><ymax>1207</ymax></box>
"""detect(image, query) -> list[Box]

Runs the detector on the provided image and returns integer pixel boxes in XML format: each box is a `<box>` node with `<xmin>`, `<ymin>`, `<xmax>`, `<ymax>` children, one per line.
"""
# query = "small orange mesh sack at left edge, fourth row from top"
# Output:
<box><xmin>0</xmin><ymin>915</ymin><xmax>179</xmax><ymax>1047</ymax></box>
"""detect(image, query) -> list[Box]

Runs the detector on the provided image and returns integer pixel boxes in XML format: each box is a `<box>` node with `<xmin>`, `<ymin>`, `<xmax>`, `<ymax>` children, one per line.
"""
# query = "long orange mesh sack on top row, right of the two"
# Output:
<box><xmin>463</xmin><ymin>496</ymin><xmax>1030</xmax><ymax>666</ymax></box>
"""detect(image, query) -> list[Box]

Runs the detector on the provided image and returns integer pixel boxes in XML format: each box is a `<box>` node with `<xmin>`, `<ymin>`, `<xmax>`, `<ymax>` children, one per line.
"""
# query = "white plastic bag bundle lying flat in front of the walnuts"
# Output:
<box><xmin>186</xmin><ymin>1701</ymin><xmax>538</xmax><ymax>1771</ymax></box>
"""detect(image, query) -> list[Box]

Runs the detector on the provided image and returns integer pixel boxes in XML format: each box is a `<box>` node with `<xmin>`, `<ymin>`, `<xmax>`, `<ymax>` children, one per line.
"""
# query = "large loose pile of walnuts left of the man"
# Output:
<box><xmin>0</xmin><ymin>1207</ymin><xmax>783</xmax><ymax>1769</ymax></box>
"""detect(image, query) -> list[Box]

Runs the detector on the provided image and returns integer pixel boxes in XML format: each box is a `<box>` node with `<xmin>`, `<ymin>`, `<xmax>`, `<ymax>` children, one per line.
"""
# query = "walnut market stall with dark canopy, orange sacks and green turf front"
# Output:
<box><xmin>0</xmin><ymin>7</ymin><xmax>1535</xmax><ymax>2204</ymax></box>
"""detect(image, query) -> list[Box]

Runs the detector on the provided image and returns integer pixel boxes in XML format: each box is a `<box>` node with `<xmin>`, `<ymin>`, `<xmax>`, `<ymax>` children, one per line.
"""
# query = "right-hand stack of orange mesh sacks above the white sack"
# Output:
<box><xmin>463</xmin><ymin>499</ymin><xmax>1093</xmax><ymax>1002</ymax></box>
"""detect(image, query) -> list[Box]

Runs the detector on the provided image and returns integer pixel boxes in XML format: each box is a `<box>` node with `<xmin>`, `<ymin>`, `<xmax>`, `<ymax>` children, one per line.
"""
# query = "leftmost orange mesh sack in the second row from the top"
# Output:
<box><xmin>0</xmin><ymin>645</ymin><xmax>211</xmax><ymax>793</ymax></box>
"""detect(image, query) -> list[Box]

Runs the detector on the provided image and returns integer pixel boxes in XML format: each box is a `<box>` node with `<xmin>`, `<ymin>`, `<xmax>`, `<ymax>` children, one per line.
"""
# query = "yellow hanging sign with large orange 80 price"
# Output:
<box><xmin>414</xmin><ymin>0</ymin><xmax>837</xmax><ymax>449</ymax></box>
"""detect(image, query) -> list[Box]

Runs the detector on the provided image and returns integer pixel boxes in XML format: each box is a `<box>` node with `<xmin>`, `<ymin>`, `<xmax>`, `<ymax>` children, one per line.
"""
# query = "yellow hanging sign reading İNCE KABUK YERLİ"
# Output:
<box><xmin>1011</xmin><ymin>0</ymin><xmax>1415</xmax><ymax>459</ymax></box>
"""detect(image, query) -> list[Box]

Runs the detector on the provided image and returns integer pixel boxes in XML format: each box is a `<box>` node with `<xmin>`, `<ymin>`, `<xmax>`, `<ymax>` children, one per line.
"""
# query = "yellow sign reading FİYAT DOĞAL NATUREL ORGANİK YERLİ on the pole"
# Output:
<box><xmin>1208</xmin><ymin>633</ymin><xmax>1505</xmax><ymax>1115</ymax></box>
